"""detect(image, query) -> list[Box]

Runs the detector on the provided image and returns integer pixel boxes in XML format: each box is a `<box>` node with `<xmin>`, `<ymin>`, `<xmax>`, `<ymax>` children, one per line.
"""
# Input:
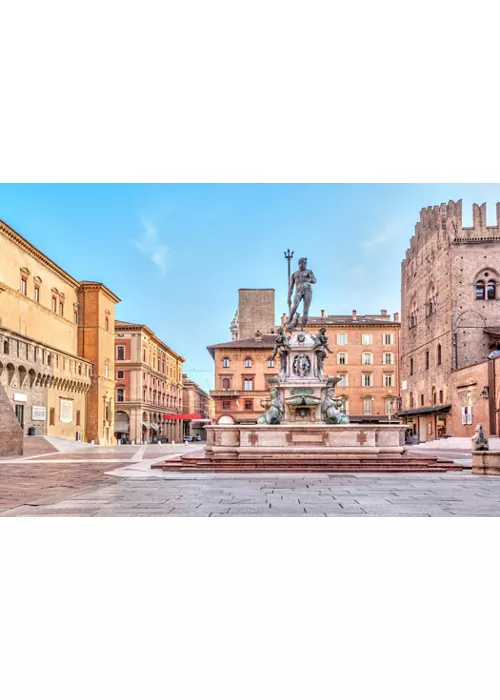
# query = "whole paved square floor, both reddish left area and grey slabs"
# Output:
<box><xmin>0</xmin><ymin>445</ymin><xmax>500</xmax><ymax>517</ymax></box>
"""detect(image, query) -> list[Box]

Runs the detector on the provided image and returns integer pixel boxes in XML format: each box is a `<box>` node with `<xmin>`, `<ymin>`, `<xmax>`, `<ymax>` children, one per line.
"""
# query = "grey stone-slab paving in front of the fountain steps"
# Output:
<box><xmin>2</xmin><ymin>467</ymin><xmax>500</xmax><ymax>517</ymax></box>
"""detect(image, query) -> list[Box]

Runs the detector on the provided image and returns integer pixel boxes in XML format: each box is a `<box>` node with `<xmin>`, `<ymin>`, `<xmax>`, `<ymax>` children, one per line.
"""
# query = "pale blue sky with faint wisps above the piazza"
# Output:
<box><xmin>0</xmin><ymin>184</ymin><xmax>500</xmax><ymax>389</ymax></box>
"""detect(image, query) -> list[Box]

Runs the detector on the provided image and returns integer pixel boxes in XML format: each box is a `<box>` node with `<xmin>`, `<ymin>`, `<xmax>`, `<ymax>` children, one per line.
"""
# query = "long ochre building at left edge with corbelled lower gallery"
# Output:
<box><xmin>0</xmin><ymin>221</ymin><xmax>119</xmax><ymax>444</ymax></box>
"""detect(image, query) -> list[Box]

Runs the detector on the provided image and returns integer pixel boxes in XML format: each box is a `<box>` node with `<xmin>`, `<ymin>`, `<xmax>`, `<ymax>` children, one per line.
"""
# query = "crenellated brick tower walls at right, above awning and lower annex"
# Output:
<box><xmin>401</xmin><ymin>200</ymin><xmax>500</xmax><ymax>439</ymax></box>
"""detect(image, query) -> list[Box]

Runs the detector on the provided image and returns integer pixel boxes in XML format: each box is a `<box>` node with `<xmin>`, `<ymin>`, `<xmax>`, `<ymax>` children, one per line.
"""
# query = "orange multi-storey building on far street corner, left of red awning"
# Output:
<box><xmin>114</xmin><ymin>321</ymin><xmax>184</xmax><ymax>442</ymax></box>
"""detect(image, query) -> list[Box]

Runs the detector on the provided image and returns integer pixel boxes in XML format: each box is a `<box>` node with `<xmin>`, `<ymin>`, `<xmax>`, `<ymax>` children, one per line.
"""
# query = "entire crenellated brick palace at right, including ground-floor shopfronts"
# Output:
<box><xmin>399</xmin><ymin>201</ymin><xmax>500</xmax><ymax>441</ymax></box>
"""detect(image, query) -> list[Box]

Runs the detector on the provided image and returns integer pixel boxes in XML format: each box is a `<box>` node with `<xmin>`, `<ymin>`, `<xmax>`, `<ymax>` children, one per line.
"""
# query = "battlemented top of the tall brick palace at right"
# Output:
<box><xmin>403</xmin><ymin>199</ymin><xmax>500</xmax><ymax>266</ymax></box>
